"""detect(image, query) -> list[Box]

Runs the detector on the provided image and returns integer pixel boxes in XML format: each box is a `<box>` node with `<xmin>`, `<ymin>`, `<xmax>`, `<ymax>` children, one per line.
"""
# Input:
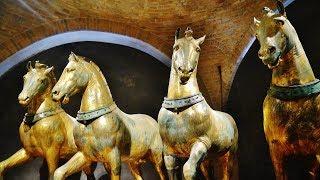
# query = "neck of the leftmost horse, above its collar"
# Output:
<box><xmin>27</xmin><ymin>77</ymin><xmax>60</xmax><ymax>114</ymax></box>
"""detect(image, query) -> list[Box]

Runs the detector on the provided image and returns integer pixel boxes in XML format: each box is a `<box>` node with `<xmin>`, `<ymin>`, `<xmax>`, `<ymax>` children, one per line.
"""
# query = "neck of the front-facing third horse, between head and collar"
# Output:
<box><xmin>167</xmin><ymin>65</ymin><xmax>200</xmax><ymax>99</ymax></box>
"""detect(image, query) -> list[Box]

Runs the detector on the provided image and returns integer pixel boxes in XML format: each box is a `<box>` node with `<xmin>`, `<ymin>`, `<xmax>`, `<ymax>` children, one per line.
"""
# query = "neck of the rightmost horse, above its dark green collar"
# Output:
<box><xmin>272</xmin><ymin>24</ymin><xmax>315</xmax><ymax>86</ymax></box>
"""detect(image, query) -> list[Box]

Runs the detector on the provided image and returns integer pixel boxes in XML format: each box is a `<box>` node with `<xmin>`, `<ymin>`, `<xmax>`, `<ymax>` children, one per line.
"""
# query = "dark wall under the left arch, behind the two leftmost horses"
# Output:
<box><xmin>0</xmin><ymin>42</ymin><xmax>170</xmax><ymax>180</ymax></box>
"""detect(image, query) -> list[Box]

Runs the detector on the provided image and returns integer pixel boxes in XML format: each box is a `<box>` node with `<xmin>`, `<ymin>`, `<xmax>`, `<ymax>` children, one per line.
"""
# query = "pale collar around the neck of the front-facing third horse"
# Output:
<box><xmin>162</xmin><ymin>93</ymin><xmax>204</xmax><ymax>109</ymax></box>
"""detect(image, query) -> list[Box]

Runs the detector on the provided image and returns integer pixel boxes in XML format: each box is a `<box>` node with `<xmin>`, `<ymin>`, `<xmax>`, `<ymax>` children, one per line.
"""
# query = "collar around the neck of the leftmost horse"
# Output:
<box><xmin>23</xmin><ymin>107</ymin><xmax>63</xmax><ymax>125</ymax></box>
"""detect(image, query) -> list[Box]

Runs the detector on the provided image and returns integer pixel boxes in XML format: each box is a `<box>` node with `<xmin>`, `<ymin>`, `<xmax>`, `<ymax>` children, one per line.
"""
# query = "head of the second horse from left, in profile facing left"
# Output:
<box><xmin>52</xmin><ymin>52</ymin><xmax>89</xmax><ymax>104</ymax></box>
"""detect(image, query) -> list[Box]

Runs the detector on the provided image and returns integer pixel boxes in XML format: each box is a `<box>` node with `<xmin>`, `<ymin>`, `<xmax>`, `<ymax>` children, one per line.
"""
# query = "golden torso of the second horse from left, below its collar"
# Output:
<box><xmin>74</xmin><ymin>108</ymin><xmax>162</xmax><ymax>164</ymax></box>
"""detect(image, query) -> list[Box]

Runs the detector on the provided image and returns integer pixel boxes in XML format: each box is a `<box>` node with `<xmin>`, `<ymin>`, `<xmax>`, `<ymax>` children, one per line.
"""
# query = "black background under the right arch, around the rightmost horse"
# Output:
<box><xmin>227</xmin><ymin>0</ymin><xmax>320</xmax><ymax>180</ymax></box>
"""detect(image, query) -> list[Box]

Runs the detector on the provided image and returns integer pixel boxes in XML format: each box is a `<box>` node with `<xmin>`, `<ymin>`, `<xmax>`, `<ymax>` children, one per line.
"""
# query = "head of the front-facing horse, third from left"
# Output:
<box><xmin>172</xmin><ymin>27</ymin><xmax>205</xmax><ymax>85</ymax></box>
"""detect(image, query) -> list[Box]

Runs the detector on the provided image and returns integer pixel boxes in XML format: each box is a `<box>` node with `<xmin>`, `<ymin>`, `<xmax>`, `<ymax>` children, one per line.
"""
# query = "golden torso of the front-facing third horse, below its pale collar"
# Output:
<box><xmin>159</xmin><ymin>101</ymin><xmax>237</xmax><ymax>157</ymax></box>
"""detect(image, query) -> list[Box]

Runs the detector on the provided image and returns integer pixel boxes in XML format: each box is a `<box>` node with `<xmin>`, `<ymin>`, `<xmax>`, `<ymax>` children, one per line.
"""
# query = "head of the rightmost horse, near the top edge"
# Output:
<box><xmin>254</xmin><ymin>1</ymin><xmax>297</xmax><ymax>69</ymax></box>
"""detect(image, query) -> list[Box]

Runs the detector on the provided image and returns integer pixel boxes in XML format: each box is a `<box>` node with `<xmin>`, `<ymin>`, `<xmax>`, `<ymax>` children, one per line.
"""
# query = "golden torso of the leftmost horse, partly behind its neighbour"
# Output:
<box><xmin>19</xmin><ymin>98</ymin><xmax>77</xmax><ymax>158</ymax></box>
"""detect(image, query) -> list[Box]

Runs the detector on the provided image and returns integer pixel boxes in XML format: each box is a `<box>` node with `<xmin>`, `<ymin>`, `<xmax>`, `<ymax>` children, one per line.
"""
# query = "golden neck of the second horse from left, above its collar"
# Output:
<box><xmin>80</xmin><ymin>64</ymin><xmax>113</xmax><ymax>112</ymax></box>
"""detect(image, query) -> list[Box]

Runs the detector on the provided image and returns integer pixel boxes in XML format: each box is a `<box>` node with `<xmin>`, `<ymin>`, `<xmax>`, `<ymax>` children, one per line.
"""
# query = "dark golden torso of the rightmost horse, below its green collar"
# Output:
<box><xmin>263</xmin><ymin>95</ymin><xmax>320</xmax><ymax>156</ymax></box>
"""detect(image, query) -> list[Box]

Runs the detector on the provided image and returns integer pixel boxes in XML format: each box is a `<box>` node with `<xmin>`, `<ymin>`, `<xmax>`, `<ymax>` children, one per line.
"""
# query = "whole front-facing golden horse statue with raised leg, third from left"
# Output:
<box><xmin>158</xmin><ymin>28</ymin><xmax>238</xmax><ymax>180</ymax></box>
